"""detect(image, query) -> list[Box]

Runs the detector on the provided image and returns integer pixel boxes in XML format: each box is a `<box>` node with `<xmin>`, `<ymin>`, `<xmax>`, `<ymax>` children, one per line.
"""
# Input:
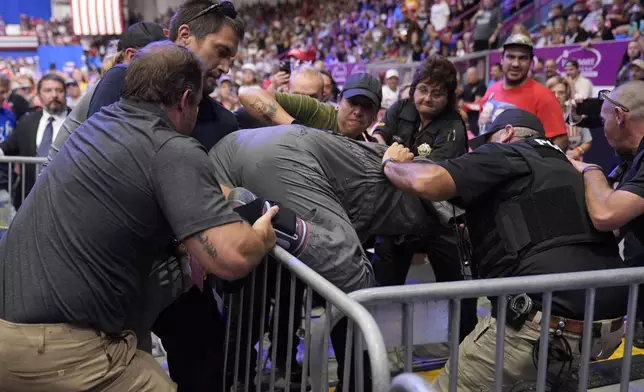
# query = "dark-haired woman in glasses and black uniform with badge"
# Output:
<box><xmin>373</xmin><ymin>55</ymin><xmax>477</xmax><ymax>338</ymax></box>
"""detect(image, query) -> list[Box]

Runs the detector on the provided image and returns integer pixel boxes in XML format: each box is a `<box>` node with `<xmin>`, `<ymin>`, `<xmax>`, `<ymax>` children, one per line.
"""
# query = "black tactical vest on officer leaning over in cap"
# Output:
<box><xmin>467</xmin><ymin>138</ymin><xmax>614</xmax><ymax>278</ymax></box>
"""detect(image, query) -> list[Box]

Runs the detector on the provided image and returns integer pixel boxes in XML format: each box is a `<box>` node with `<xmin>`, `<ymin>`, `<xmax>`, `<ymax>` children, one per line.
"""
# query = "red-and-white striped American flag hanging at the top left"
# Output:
<box><xmin>71</xmin><ymin>0</ymin><xmax>123</xmax><ymax>36</ymax></box>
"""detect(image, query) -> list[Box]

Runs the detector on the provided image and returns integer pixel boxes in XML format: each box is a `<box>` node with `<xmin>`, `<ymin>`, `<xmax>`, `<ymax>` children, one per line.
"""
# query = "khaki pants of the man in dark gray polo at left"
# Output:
<box><xmin>0</xmin><ymin>320</ymin><xmax>177</xmax><ymax>392</ymax></box>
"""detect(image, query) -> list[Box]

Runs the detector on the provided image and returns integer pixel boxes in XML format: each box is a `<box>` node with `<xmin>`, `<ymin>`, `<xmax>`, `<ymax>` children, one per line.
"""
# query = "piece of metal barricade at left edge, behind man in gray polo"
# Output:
<box><xmin>0</xmin><ymin>156</ymin><xmax>47</xmax><ymax>236</ymax></box>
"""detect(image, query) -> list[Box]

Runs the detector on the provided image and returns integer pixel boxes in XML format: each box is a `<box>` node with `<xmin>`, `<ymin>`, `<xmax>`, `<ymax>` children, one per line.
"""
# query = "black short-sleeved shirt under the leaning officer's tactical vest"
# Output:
<box><xmin>438</xmin><ymin>140</ymin><xmax>628</xmax><ymax>320</ymax></box>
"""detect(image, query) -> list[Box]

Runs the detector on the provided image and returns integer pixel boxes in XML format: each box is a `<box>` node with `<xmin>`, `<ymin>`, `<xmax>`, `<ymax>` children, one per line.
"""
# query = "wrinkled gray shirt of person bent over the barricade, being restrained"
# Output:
<box><xmin>209</xmin><ymin>125</ymin><xmax>435</xmax><ymax>292</ymax></box>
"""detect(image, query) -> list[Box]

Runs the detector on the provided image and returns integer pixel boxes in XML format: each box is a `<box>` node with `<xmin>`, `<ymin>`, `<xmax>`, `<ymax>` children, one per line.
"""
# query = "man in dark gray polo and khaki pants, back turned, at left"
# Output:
<box><xmin>0</xmin><ymin>42</ymin><xmax>277</xmax><ymax>391</ymax></box>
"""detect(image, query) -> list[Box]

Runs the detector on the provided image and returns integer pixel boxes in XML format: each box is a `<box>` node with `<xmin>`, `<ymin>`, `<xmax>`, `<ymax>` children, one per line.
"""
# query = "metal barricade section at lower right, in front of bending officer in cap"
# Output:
<box><xmin>311</xmin><ymin>267</ymin><xmax>644</xmax><ymax>392</ymax></box>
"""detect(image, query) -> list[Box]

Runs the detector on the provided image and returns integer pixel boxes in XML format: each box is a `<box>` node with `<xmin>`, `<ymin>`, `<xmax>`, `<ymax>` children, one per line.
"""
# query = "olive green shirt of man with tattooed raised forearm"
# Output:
<box><xmin>275</xmin><ymin>93</ymin><xmax>340</xmax><ymax>132</ymax></box>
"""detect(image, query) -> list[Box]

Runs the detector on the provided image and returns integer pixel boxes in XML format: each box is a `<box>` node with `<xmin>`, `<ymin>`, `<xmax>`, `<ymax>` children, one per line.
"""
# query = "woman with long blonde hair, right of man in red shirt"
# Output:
<box><xmin>546</xmin><ymin>76</ymin><xmax>593</xmax><ymax>161</ymax></box>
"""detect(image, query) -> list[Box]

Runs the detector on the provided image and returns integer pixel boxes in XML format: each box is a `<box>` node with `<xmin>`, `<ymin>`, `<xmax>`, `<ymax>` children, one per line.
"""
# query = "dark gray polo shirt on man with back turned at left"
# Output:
<box><xmin>0</xmin><ymin>100</ymin><xmax>241</xmax><ymax>333</ymax></box>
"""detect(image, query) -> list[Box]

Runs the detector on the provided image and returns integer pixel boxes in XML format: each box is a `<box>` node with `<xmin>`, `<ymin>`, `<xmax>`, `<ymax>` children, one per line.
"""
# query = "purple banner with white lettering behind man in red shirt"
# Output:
<box><xmin>490</xmin><ymin>41</ymin><xmax>629</xmax><ymax>86</ymax></box>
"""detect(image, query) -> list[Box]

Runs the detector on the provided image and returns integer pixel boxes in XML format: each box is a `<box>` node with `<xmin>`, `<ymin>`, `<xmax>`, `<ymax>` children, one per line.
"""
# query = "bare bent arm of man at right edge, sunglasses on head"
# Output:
<box><xmin>583</xmin><ymin>170</ymin><xmax>644</xmax><ymax>231</ymax></box>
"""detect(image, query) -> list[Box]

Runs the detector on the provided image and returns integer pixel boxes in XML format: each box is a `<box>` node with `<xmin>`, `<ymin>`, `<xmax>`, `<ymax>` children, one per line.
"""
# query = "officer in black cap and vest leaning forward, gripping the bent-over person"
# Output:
<box><xmin>383</xmin><ymin>109</ymin><xmax>628</xmax><ymax>391</ymax></box>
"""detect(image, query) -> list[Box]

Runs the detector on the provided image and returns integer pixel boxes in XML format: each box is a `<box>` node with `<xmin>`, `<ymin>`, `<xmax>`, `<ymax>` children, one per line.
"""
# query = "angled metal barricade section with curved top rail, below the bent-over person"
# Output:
<box><xmin>219</xmin><ymin>246</ymin><xmax>390</xmax><ymax>392</ymax></box>
